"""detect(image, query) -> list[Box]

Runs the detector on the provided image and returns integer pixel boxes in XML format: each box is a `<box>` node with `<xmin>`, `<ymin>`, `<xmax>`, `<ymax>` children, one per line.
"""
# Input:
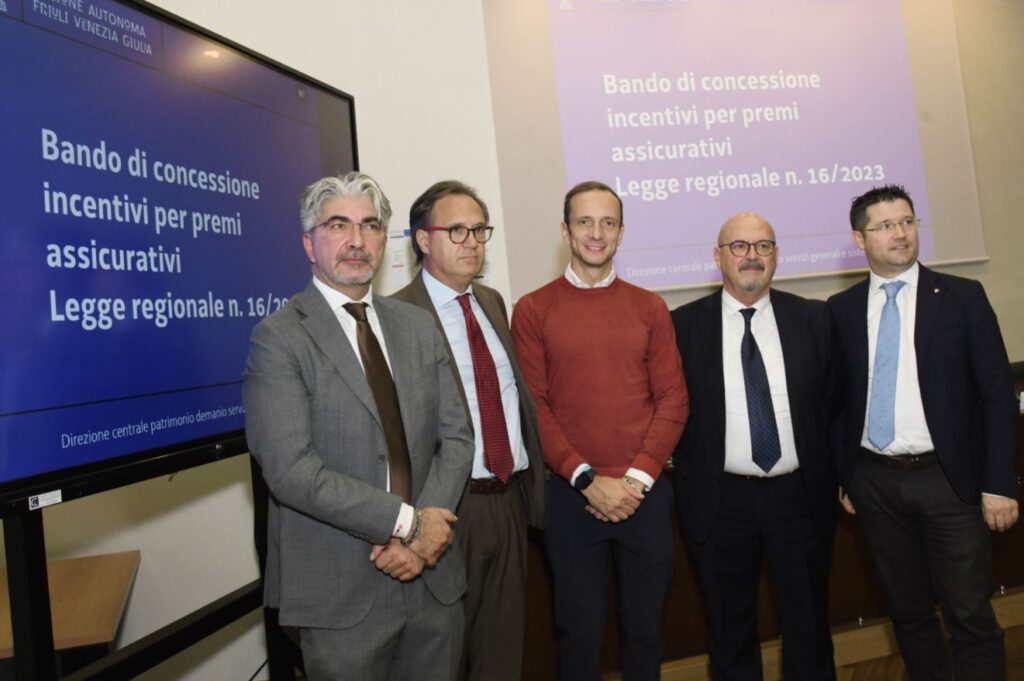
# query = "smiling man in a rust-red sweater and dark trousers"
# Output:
<box><xmin>512</xmin><ymin>182</ymin><xmax>689</xmax><ymax>681</ymax></box>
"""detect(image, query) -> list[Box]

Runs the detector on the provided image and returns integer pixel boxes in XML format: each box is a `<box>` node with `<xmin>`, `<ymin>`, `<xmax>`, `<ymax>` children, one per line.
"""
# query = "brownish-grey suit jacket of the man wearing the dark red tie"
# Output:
<box><xmin>392</xmin><ymin>269</ymin><xmax>548</xmax><ymax>529</ymax></box>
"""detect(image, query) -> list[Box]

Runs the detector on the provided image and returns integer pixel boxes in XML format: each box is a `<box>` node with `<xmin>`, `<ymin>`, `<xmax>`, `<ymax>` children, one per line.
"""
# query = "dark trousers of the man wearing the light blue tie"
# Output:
<box><xmin>849</xmin><ymin>448</ymin><xmax>1007</xmax><ymax>681</ymax></box>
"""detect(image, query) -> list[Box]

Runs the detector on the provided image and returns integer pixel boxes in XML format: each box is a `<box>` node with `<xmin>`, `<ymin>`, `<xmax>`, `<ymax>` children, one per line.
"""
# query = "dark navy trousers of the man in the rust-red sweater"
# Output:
<box><xmin>544</xmin><ymin>475</ymin><xmax>675</xmax><ymax>681</ymax></box>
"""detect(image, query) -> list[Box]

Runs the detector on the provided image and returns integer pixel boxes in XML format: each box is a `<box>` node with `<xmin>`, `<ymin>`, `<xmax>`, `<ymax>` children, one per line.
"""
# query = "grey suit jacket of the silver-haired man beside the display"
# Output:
<box><xmin>243</xmin><ymin>283</ymin><xmax>473</xmax><ymax>629</ymax></box>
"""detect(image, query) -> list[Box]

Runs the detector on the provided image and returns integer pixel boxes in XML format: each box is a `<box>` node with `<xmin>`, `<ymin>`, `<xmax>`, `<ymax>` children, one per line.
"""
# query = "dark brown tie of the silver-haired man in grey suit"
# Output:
<box><xmin>345</xmin><ymin>303</ymin><xmax>413</xmax><ymax>503</ymax></box>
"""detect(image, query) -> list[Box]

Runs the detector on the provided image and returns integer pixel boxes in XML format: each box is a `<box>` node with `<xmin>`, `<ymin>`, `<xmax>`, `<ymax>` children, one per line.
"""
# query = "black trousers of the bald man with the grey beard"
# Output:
<box><xmin>688</xmin><ymin>472</ymin><xmax>836</xmax><ymax>681</ymax></box>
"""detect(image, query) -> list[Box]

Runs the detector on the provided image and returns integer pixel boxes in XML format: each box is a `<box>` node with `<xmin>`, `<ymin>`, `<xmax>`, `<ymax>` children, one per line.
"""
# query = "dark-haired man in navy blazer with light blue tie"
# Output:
<box><xmin>828</xmin><ymin>185</ymin><xmax>1020</xmax><ymax>681</ymax></box>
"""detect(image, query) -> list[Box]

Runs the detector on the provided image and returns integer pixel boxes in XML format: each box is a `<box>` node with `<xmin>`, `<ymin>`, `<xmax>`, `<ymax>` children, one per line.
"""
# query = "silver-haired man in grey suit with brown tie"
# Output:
<box><xmin>244</xmin><ymin>172</ymin><xmax>473</xmax><ymax>681</ymax></box>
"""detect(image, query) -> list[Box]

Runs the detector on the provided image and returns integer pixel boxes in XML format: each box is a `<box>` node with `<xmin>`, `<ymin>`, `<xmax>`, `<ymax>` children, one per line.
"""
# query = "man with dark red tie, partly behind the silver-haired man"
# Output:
<box><xmin>394</xmin><ymin>180</ymin><xmax>547</xmax><ymax>681</ymax></box>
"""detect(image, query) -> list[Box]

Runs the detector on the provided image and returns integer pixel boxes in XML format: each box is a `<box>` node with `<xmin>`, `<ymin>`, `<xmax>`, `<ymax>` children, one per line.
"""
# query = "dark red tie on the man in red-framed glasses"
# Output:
<box><xmin>459</xmin><ymin>293</ymin><xmax>512</xmax><ymax>482</ymax></box>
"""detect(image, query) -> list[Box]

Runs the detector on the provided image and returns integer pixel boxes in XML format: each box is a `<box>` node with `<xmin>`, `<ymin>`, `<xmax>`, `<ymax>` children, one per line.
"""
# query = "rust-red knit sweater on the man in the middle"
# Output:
<box><xmin>512</xmin><ymin>276</ymin><xmax>689</xmax><ymax>479</ymax></box>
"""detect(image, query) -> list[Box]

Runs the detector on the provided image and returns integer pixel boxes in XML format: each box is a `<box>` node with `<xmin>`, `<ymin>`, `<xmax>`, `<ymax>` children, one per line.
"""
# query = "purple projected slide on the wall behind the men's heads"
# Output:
<box><xmin>548</xmin><ymin>0</ymin><xmax>933</xmax><ymax>289</ymax></box>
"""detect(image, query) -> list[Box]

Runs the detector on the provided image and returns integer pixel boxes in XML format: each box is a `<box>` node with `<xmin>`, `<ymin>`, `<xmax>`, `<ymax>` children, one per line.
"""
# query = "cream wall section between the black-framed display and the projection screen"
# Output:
<box><xmin>155</xmin><ymin>0</ymin><xmax>508</xmax><ymax>301</ymax></box>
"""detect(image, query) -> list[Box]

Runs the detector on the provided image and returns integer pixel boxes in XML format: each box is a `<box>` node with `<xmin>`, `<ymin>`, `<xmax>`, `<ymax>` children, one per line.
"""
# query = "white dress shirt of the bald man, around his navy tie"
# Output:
<box><xmin>722</xmin><ymin>291</ymin><xmax>800</xmax><ymax>477</ymax></box>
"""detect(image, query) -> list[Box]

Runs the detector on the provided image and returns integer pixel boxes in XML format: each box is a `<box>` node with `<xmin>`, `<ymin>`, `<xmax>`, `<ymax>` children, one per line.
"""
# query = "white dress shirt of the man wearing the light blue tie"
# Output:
<box><xmin>860</xmin><ymin>263</ymin><xmax>935</xmax><ymax>455</ymax></box>
